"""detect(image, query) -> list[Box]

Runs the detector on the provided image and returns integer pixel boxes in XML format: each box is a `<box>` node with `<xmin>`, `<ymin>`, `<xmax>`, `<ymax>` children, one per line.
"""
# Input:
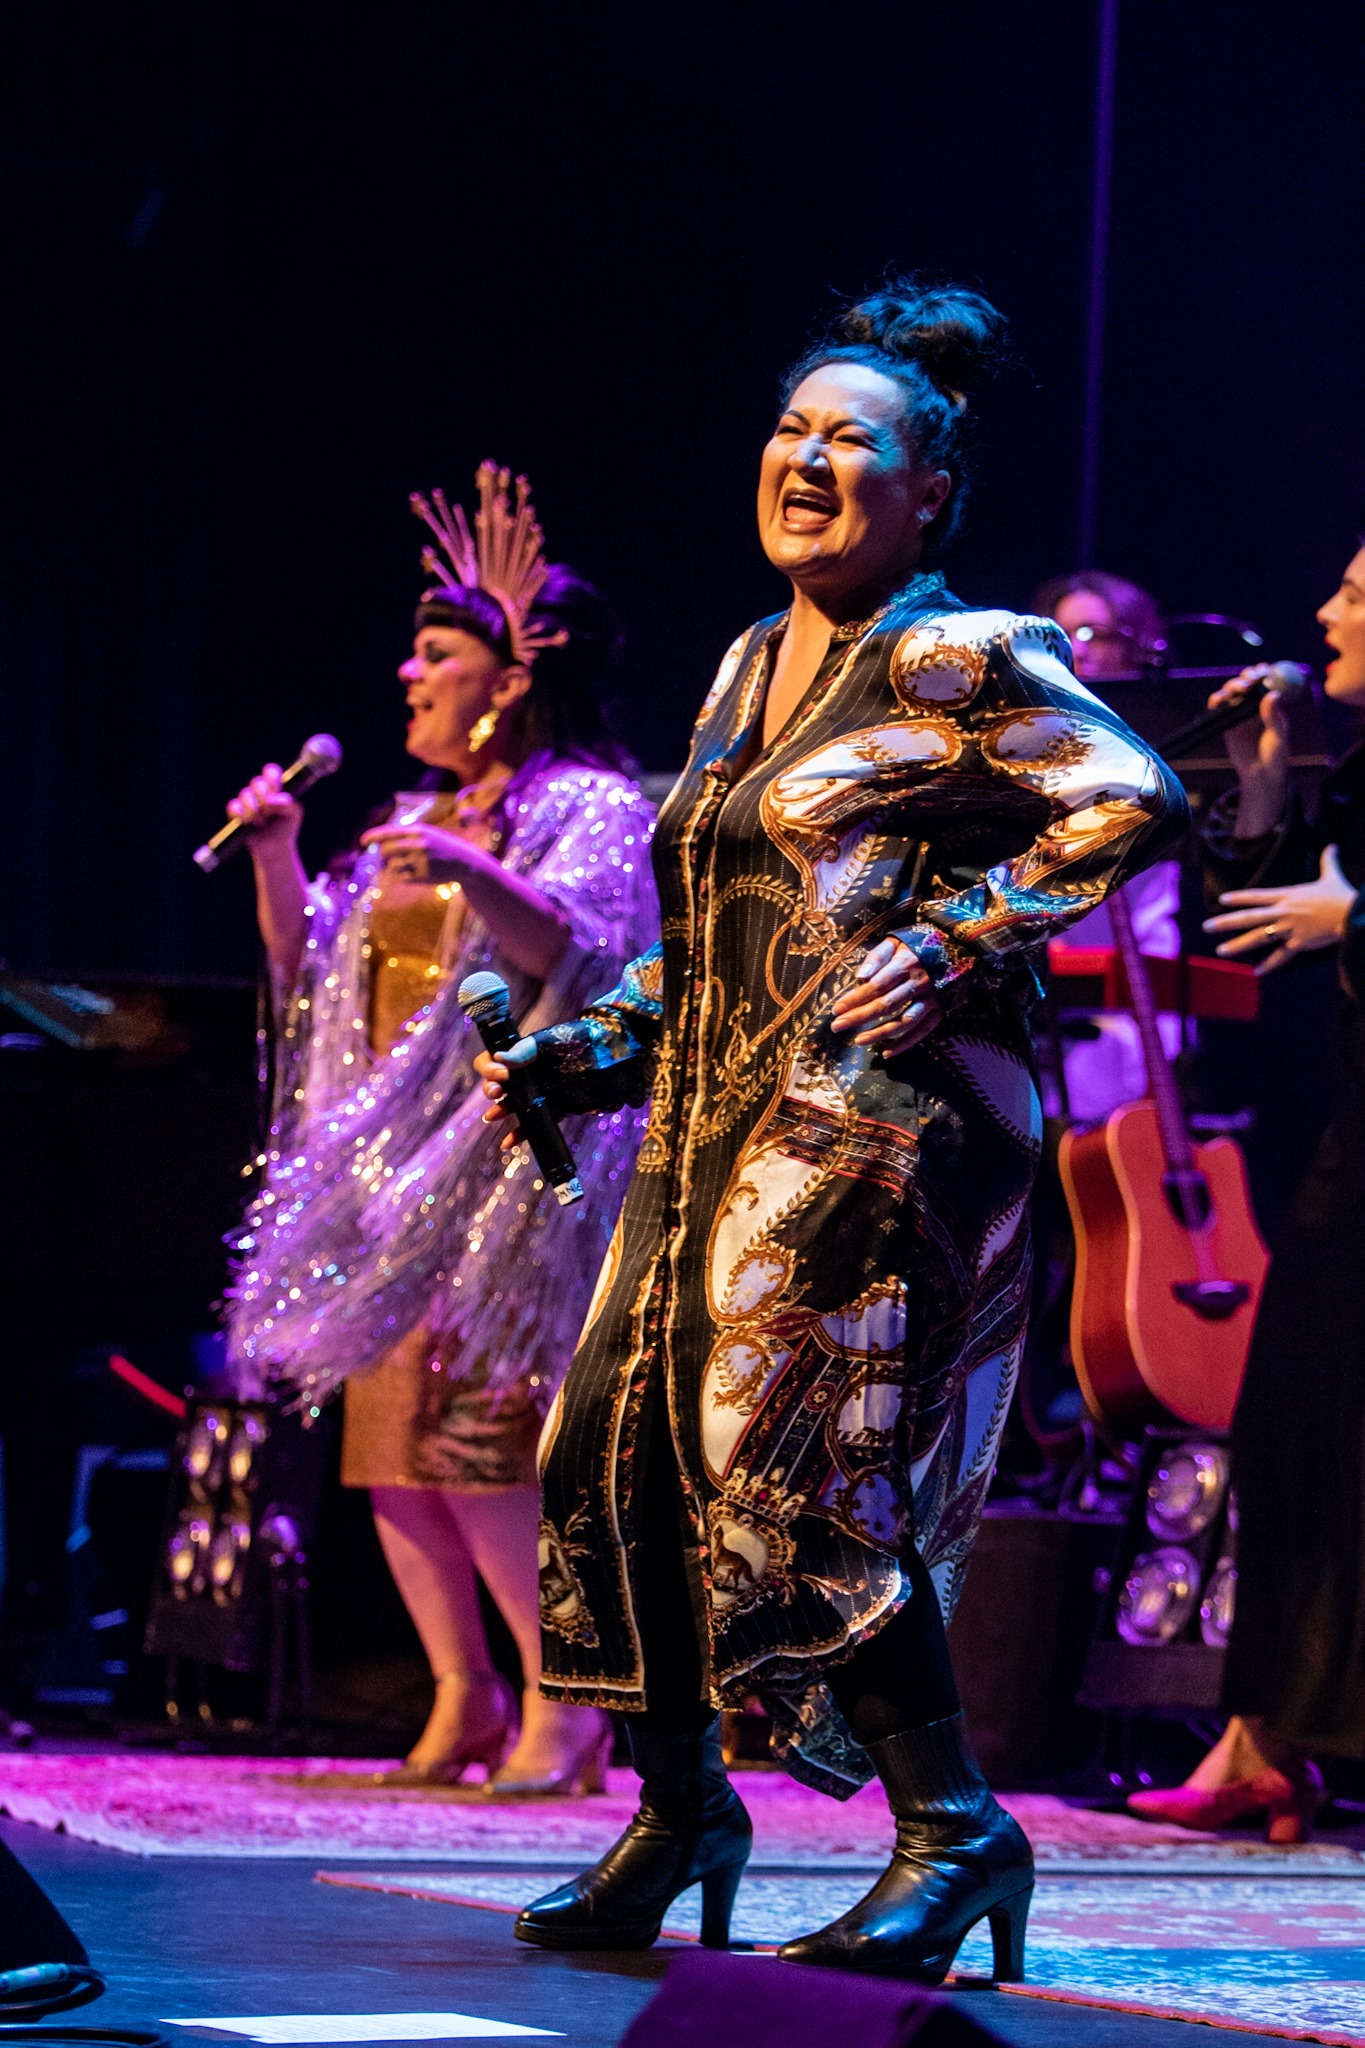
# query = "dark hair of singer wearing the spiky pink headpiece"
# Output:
<box><xmin>415</xmin><ymin>561</ymin><xmax>626</xmax><ymax>768</ymax></box>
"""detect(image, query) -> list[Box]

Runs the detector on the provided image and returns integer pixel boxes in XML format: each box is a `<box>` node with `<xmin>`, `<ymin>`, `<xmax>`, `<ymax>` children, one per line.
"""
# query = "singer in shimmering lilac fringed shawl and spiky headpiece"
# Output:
<box><xmin>229</xmin><ymin>465</ymin><xmax>659</xmax><ymax>1792</ymax></box>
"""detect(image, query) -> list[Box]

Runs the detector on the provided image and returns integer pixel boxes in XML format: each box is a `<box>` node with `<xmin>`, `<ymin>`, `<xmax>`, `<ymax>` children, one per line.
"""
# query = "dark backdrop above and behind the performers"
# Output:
<box><xmin>0</xmin><ymin>0</ymin><xmax>1365</xmax><ymax>991</ymax></box>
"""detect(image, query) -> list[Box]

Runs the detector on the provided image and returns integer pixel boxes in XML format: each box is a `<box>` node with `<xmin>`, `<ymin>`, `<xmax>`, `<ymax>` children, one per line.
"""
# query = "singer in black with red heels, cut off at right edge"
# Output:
<box><xmin>1130</xmin><ymin>545</ymin><xmax>1365</xmax><ymax>1841</ymax></box>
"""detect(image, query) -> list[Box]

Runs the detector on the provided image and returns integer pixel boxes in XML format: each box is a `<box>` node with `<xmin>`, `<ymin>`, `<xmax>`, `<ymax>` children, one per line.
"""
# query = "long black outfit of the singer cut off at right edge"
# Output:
<box><xmin>1205</xmin><ymin>745</ymin><xmax>1365</xmax><ymax>1757</ymax></box>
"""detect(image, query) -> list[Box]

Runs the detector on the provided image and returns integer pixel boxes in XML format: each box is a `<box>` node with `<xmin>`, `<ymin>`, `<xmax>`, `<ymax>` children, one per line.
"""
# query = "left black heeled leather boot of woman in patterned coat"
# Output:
<box><xmin>514</xmin><ymin>1714</ymin><xmax>753</xmax><ymax>1948</ymax></box>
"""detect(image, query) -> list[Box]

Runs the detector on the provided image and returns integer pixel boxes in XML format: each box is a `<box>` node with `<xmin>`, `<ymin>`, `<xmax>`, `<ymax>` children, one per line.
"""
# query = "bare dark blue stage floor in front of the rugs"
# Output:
<box><xmin>0</xmin><ymin>1821</ymin><xmax>1301</xmax><ymax>2048</ymax></box>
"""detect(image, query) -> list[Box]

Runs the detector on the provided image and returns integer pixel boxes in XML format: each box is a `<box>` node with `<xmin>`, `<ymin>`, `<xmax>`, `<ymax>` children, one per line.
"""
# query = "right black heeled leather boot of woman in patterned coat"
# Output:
<box><xmin>778</xmin><ymin>1714</ymin><xmax>1033</xmax><ymax>1985</ymax></box>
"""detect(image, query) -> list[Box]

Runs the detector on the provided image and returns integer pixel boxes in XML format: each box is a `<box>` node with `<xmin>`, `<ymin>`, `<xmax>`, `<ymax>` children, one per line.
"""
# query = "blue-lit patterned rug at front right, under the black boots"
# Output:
<box><xmin>319</xmin><ymin>1875</ymin><xmax>1365</xmax><ymax>2048</ymax></box>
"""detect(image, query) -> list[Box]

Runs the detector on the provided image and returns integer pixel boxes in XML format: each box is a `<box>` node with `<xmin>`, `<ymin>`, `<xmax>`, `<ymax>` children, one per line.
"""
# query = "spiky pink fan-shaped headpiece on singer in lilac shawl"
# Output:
<box><xmin>409</xmin><ymin>463</ymin><xmax>569</xmax><ymax>666</ymax></box>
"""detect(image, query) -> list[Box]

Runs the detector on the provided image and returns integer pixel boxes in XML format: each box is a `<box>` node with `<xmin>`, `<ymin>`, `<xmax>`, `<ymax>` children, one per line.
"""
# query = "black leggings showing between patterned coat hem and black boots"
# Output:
<box><xmin>636</xmin><ymin>1393</ymin><xmax>958</xmax><ymax>1743</ymax></box>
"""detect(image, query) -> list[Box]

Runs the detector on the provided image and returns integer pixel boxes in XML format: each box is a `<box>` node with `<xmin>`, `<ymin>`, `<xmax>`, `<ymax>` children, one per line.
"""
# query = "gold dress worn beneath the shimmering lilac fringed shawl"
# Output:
<box><xmin>342</xmin><ymin>793</ymin><xmax>540</xmax><ymax>1493</ymax></box>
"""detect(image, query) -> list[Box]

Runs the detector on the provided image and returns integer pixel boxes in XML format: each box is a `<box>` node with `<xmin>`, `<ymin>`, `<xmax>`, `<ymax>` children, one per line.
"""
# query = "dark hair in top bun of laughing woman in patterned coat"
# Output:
<box><xmin>782</xmin><ymin>276</ymin><xmax>1005</xmax><ymax>549</ymax></box>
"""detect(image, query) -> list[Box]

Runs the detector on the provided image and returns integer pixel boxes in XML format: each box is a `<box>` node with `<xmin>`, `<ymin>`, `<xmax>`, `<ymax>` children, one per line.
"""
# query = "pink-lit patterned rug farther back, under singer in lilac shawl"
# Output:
<box><xmin>0</xmin><ymin>1751</ymin><xmax>1365</xmax><ymax>1878</ymax></box>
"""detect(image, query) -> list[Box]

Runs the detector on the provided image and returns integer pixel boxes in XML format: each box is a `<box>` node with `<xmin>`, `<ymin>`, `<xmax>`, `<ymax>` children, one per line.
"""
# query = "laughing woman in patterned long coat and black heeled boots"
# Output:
<box><xmin>477</xmin><ymin>283</ymin><xmax>1185</xmax><ymax>1980</ymax></box>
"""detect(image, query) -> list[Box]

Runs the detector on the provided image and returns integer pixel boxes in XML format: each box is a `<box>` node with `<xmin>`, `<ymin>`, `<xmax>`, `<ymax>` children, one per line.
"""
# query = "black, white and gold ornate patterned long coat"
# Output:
<box><xmin>538</xmin><ymin>575</ymin><xmax>1187</xmax><ymax>1796</ymax></box>
